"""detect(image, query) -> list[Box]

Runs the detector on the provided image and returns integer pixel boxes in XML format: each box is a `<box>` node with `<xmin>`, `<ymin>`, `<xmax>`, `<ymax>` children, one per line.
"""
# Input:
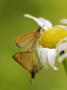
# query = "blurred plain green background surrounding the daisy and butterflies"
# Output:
<box><xmin>0</xmin><ymin>0</ymin><xmax>67</xmax><ymax>90</ymax></box>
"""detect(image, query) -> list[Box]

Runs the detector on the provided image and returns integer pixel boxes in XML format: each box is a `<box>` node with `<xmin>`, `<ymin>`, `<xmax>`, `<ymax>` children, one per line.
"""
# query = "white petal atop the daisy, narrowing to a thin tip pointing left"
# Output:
<box><xmin>24</xmin><ymin>14</ymin><xmax>52</xmax><ymax>30</ymax></box>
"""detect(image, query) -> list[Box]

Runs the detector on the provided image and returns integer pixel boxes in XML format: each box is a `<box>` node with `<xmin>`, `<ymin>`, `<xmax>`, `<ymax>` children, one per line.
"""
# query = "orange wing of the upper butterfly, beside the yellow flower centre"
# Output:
<box><xmin>15</xmin><ymin>30</ymin><xmax>38</xmax><ymax>51</ymax></box>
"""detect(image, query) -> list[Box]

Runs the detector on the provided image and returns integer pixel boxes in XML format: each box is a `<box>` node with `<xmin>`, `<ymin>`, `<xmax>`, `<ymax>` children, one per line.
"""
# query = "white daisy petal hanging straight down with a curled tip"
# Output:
<box><xmin>48</xmin><ymin>49</ymin><xmax>57</xmax><ymax>70</ymax></box>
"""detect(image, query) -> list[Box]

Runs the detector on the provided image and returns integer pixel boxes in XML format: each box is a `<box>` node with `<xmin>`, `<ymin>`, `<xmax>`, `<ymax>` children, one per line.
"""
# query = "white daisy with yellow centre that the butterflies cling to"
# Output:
<box><xmin>24</xmin><ymin>14</ymin><xmax>67</xmax><ymax>70</ymax></box>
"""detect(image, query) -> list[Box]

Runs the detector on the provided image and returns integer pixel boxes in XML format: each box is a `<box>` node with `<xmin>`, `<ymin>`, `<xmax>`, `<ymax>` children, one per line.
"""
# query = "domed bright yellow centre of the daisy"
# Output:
<box><xmin>39</xmin><ymin>28</ymin><xmax>67</xmax><ymax>48</ymax></box>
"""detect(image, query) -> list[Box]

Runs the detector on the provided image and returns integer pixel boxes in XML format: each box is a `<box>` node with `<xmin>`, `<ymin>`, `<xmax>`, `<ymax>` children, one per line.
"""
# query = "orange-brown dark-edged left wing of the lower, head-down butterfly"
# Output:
<box><xmin>13</xmin><ymin>52</ymin><xmax>33</xmax><ymax>72</ymax></box>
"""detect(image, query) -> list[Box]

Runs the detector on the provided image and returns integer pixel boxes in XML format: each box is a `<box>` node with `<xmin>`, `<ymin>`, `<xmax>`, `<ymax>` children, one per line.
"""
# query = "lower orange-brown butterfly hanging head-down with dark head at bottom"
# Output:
<box><xmin>13</xmin><ymin>51</ymin><xmax>40</xmax><ymax>78</ymax></box>
